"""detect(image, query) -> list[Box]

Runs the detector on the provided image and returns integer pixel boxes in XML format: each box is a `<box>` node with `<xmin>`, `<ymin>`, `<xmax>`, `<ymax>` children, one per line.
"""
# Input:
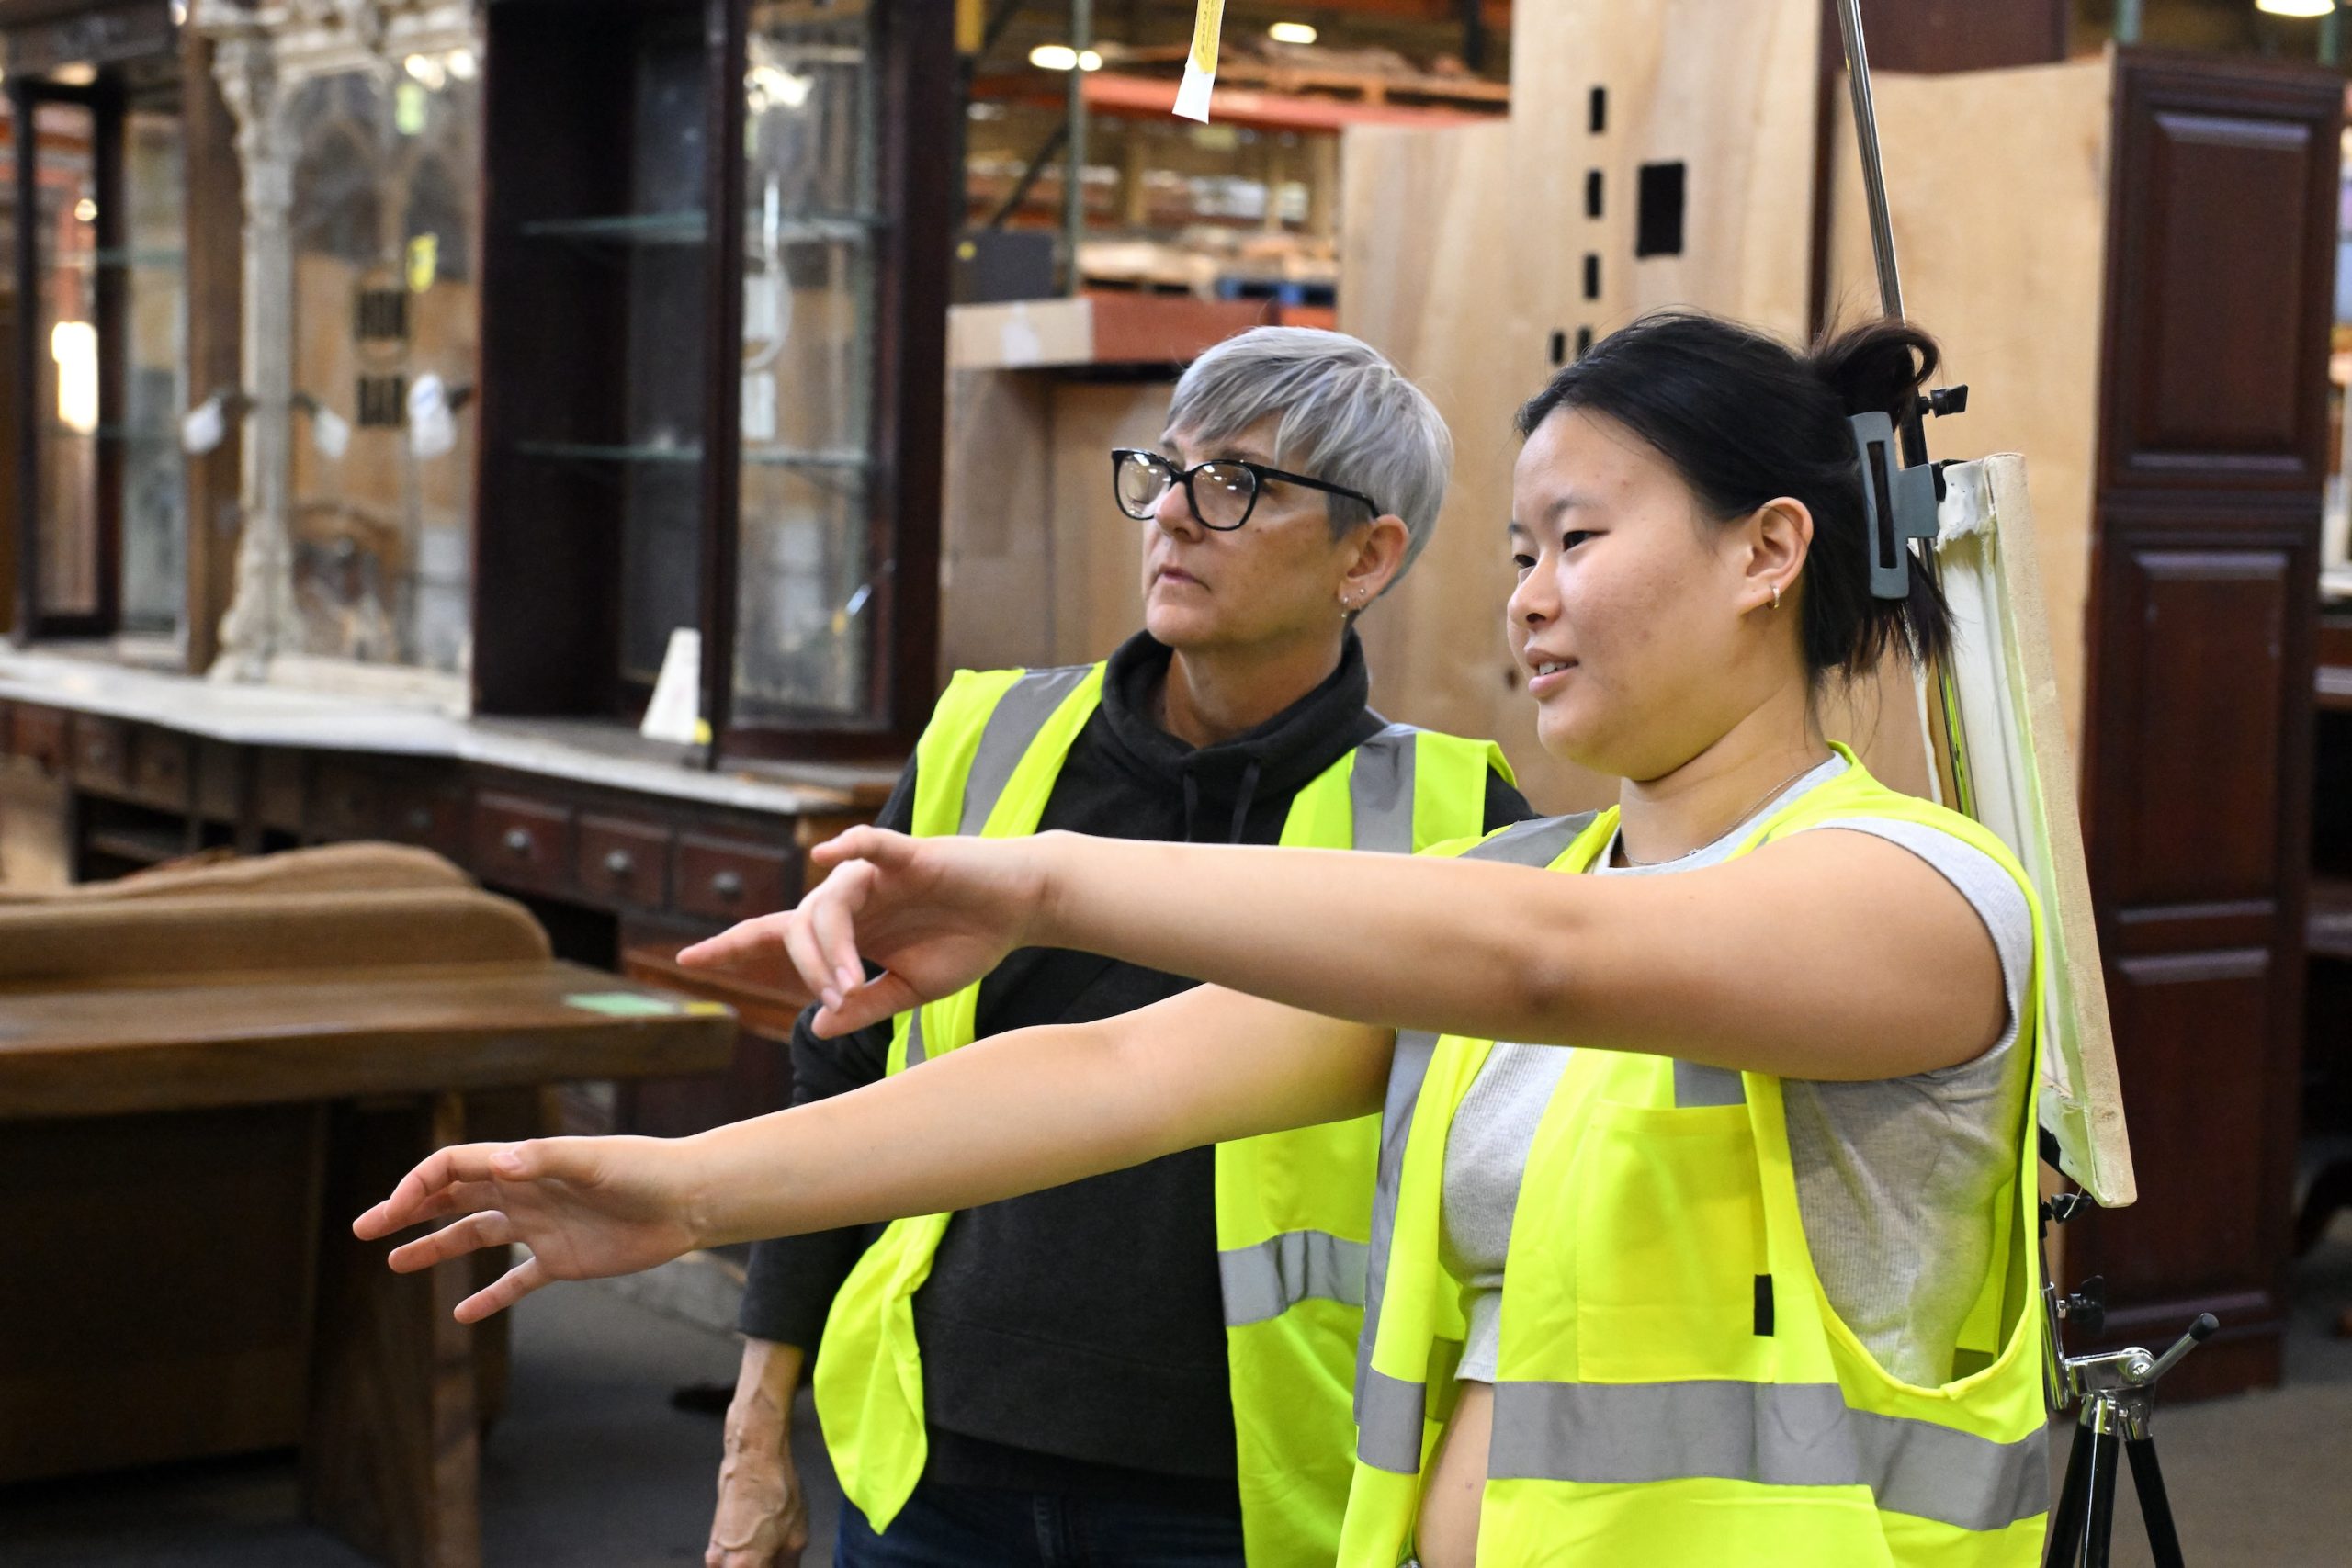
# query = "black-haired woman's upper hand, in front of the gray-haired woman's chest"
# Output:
<box><xmin>677</xmin><ymin>828</ymin><xmax>1045</xmax><ymax>1034</ymax></box>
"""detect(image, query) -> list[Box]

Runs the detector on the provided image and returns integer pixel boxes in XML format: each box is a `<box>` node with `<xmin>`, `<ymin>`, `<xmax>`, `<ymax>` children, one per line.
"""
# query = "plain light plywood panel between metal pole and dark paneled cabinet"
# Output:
<box><xmin>1827</xmin><ymin>62</ymin><xmax>2112</xmax><ymax>757</ymax></box>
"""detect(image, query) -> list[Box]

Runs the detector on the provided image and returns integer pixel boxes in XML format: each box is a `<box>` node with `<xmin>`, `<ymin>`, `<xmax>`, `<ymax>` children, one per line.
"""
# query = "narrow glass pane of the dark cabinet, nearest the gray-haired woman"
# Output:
<box><xmin>734</xmin><ymin>0</ymin><xmax>877</xmax><ymax>724</ymax></box>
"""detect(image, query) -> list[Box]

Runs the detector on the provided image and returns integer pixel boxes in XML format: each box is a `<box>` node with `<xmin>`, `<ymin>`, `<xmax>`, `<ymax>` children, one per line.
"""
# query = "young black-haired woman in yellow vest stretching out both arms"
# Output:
<box><xmin>360</xmin><ymin>315</ymin><xmax>2046</xmax><ymax>1568</ymax></box>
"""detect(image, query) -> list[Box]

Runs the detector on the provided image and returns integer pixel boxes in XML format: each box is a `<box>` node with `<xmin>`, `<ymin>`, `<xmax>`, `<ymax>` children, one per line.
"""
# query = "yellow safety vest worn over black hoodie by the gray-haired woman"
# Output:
<box><xmin>814</xmin><ymin>665</ymin><xmax>1510</xmax><ymax>1568</ymax></box>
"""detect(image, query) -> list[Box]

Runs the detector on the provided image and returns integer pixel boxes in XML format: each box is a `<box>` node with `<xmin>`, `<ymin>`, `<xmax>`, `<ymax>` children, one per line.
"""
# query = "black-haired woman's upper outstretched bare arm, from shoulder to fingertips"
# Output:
<box><xmin>684</xmin><ymin>828</ymin><xmax>2007</xmax><ymax>1079</ymax></box>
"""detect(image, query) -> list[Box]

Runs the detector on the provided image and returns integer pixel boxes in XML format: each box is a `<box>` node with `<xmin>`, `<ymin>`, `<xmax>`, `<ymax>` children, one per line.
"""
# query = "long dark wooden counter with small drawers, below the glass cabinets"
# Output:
<box><xmin>0</xmin><ymin>677</ymin><xmax>891</xmax><ymax>1134</ymax></box>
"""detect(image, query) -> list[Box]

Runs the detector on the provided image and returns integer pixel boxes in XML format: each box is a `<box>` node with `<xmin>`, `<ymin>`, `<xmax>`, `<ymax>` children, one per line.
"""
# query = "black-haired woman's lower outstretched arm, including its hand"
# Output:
<box><xmin>353</xmin><ymin>987</ymin><xmax>1393</xmax><ymax>1324</ymax></box>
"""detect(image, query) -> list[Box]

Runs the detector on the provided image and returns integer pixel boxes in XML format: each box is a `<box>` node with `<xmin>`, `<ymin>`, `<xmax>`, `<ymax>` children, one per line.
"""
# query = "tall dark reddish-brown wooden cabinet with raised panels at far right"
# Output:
<box><xmin>2067</xmin><ymin>51</ymin><xmax>2343</xmax><ymax>1394</ymax></box>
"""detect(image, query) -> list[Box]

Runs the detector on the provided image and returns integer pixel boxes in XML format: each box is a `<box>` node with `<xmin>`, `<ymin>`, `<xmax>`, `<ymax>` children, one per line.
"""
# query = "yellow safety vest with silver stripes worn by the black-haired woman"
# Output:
<box><xmin>1339</xmin><ymin>748</ymin><xmax>2049</xmax><ymax>1568</ymax></box>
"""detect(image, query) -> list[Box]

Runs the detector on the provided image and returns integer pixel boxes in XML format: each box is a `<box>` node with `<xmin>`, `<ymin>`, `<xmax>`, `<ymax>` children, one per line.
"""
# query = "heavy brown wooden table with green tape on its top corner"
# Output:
<box><xmin>0</xmin><ymin>949</ymin><xmax>734</xmax><ymax>1568</ymax></box>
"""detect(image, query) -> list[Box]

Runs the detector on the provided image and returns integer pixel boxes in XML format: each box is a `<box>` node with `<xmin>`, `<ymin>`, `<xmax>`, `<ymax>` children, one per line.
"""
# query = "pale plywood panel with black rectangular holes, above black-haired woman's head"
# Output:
<box><xmin>1508</xmin><ymin>0</ymin><xmax>1820</xmax><ymax>392</ymax></box>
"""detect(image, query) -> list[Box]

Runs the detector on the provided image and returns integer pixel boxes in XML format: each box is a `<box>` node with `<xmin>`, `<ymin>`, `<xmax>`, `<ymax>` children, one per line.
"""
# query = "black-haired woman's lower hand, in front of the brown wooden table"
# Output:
<box><xmin>350</xmin><ymin>1138</ymin><xmax>696</xmax><ymax>1324</ymax></box>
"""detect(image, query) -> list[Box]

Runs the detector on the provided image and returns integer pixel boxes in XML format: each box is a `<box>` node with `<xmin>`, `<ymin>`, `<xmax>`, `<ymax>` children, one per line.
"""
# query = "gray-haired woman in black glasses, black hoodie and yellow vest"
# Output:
<box><xmin>686</xmin><ymin>327</ymin><xmax>1529</xmax><ymax>1568</ymax></box>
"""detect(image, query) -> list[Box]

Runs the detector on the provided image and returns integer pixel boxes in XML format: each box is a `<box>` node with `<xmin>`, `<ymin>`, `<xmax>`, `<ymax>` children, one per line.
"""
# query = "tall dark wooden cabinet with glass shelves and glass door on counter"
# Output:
<box><xmin>473</xmin><ymin>0</ymin><xmax>959</xmax><ymax>757</ymax></box>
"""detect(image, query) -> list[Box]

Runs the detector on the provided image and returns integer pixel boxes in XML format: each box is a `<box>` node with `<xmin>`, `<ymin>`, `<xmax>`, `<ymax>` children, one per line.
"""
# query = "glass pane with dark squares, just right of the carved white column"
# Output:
<box><xmin>287</xmin><ymin>50</ymin><xmax>480</xmax><ymax>672</ymax></box>
